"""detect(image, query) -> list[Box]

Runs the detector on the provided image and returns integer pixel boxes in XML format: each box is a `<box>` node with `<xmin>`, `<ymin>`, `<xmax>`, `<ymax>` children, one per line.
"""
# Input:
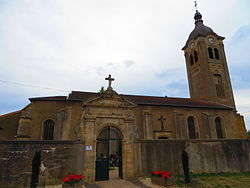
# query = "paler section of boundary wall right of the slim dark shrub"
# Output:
<box><xmin>186</xmin><ymin>139</ymin><xmax>250</xmax><ymax>173</ymax></box>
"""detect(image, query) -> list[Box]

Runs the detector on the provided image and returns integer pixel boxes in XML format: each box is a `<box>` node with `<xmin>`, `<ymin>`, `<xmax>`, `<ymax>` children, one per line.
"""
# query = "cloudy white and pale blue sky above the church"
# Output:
<box><xmin>0</xmin><ymin>0</ymin><xmax>250</xmax><ymax>129</ymax></box>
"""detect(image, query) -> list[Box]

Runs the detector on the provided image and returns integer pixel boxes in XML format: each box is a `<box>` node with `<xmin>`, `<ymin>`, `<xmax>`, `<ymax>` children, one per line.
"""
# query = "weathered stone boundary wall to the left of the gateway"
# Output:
<box><xmin>0</xmin><ymin>141</ymin><xmax>84</xmax><ymax>188</ymax></box>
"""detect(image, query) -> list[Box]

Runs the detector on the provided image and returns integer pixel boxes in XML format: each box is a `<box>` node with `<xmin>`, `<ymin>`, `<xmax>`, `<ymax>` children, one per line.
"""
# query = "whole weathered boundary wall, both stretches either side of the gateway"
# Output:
<box><xmin>0</xmin><ymin>139</ymin><xmax>250</xmax><ymax>188</ymax></box>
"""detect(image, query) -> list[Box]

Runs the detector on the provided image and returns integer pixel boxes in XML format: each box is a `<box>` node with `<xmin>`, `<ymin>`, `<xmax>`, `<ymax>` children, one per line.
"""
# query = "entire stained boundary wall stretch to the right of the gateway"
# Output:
<box><xmin>134</xmin><ymin>139</ymin><xmax>250</xmax><ymax>176</ymax></box>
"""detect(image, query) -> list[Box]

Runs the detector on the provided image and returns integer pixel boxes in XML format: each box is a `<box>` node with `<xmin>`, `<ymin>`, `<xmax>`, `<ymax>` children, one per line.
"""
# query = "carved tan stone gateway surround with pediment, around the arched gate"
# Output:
<box><xmin>78</xmin><ymin>92</ymin><xmax>138</xmax><ymax>182</ymax></box>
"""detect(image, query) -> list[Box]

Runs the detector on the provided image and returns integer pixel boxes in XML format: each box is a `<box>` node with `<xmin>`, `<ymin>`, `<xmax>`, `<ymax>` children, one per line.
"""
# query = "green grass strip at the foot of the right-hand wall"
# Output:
<box><xmin>164</xmin><ymin>172</ymin><xmax>250</xmax><ymax>188</ymax></box>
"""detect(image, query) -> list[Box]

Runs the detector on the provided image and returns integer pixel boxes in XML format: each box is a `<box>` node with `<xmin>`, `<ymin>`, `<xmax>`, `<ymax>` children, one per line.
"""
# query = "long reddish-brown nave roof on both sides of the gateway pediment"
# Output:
<box><xmin>68</xmin><ymin>91</ymin><xmax>233</xmax><ymax>110</ymax></box>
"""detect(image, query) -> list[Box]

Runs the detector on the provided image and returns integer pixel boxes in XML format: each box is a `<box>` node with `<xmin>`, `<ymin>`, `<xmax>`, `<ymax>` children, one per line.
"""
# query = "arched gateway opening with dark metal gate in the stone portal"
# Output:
<box><xmin>95</xmin><ymin>126</ymin><xmax>123</xmax><ymax>181</ymax></box>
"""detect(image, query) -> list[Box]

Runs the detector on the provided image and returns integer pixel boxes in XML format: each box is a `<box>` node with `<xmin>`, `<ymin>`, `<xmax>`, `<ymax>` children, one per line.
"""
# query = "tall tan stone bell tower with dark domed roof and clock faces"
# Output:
<box><xmin>182</xmin><ymin>10</ymin><xmax>235</xmax><ymax>108</ymax></box>
